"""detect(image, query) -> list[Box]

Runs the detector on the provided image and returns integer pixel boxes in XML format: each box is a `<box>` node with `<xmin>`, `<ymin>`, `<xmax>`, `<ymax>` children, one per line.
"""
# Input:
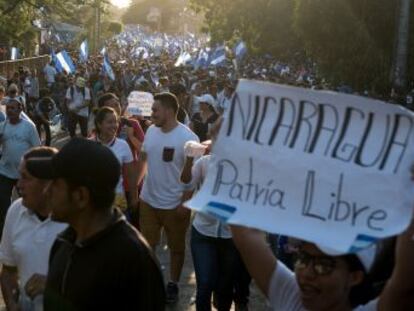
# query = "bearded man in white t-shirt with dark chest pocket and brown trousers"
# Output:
<box><xmin>138</xmin><ymin>93</ymin><xmax>198</xmax><ymax>303</ymax></box>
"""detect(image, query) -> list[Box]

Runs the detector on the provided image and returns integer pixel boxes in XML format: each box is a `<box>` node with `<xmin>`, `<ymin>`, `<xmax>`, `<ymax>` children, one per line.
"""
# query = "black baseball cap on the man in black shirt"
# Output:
<box><xmin>26</xmin><ymin>138</ymin><xmax>121</xmax><ymax>191</ymax></box>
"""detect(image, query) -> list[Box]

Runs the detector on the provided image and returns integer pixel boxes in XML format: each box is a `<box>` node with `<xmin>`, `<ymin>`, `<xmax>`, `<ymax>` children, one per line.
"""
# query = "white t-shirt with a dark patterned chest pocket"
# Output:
<box><xmin>140</xmin><ymin>123</ymin><xmax>198</xmax><ymax>209</ymax></box>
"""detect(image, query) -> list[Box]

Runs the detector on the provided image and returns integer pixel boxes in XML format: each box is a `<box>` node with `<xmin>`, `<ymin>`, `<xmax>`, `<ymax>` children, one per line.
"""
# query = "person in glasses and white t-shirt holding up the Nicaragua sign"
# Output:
<box><xmin>232</xmin><ymin>223</ymin><xmax>414</xmax><ymax>311</ymax></box>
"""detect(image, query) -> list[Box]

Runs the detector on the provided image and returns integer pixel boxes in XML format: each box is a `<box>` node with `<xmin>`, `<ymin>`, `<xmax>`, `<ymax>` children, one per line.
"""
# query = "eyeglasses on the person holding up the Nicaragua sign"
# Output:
<box><xmin>295</xmin><ymin>251</ymin><xmax>336</xmax><ymax>276</ymax></box>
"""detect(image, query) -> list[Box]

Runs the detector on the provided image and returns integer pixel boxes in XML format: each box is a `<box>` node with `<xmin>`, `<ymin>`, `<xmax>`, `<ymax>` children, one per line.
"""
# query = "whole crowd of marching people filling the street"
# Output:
<box><xmin>0</xmin><ymin>26</ymin><xmax>414</xmax><ymax>311</ymax></box>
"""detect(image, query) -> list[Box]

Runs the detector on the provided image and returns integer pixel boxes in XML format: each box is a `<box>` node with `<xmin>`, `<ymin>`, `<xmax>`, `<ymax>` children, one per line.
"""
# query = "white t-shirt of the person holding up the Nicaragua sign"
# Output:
<box><xmin>268</xmin><ymin>261</ymin><xmax>378</xmax><ymax>311</ymax></box>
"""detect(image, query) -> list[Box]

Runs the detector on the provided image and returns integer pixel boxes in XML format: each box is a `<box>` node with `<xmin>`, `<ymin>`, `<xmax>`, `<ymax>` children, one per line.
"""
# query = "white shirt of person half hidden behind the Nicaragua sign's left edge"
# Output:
<box><xmin>191</xmin><ymin>155</ymin><xmax>232</xmax><ymax>239</ymax></box>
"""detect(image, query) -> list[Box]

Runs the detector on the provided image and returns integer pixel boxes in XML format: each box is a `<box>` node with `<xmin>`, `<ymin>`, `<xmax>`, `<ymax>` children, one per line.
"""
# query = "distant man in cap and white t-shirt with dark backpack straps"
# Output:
<box><xmin>66</xmin><ymin>77</ymin><xmax>91</xmax><ymax>138</ymax></box>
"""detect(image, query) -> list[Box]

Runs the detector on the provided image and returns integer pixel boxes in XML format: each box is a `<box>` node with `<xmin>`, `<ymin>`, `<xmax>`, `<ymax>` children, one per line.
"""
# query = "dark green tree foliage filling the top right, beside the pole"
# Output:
<box><xmin>191</xmin><ymin>0</ymin><xmax>414</xmax><ymax>93</ymax></box>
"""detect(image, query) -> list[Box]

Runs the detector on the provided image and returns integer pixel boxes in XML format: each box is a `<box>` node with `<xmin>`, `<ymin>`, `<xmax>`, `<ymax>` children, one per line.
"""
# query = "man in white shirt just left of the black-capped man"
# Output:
<box><xmin>0</xmin><ymin>147</ymin><xmax>66</xmax><ymax>311</ymax></box>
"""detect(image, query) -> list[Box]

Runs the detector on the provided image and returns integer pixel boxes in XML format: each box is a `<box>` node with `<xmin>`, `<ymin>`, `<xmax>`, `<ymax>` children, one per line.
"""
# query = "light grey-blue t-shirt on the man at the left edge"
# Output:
<box><xmin>0</xmin><ymin>118</ymin><xmax>40</xmax><ymax>179</ymax></box>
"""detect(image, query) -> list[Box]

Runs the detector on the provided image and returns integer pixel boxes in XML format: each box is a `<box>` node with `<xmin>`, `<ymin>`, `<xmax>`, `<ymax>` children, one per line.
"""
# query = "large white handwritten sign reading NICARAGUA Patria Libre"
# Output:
<box><xmin>186</xmin><ymin>80</ymin><xmax>414</xmax><ymax>253</ymax></box>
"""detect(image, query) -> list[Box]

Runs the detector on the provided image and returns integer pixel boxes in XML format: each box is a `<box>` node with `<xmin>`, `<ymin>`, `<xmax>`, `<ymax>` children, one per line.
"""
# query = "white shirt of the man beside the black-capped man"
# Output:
<box><xmin>0</xmin><ymin>199</ymin><xmax>67</xmax><ymax>310</ymax></box>
